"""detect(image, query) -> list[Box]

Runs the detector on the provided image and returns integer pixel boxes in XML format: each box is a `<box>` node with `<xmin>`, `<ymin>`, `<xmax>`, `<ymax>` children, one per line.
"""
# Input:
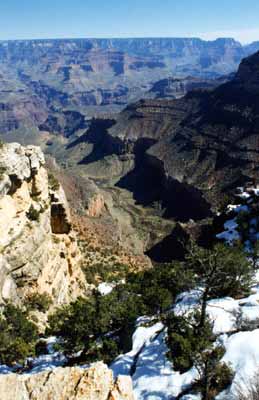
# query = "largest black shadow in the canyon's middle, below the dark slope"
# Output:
<box><xmin>117</xmin><ymin>139</ymin><xmax>211</xmax><ymax>222</ymax></box>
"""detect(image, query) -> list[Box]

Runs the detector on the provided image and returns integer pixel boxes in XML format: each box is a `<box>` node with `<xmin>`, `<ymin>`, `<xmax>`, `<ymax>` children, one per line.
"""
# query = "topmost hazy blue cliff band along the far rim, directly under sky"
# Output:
<box><xmin>0</xmin><ymin>38</ymin><xmax>249</xmax><ymax>76</ymax></box>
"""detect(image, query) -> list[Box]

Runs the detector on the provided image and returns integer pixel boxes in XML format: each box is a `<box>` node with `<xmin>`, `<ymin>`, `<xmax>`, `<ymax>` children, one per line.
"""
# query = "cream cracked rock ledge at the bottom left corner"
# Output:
<box><xmin>0</xmin><ymin>362</ymin><xmax>134</xmax><ymax>400</ymax></box>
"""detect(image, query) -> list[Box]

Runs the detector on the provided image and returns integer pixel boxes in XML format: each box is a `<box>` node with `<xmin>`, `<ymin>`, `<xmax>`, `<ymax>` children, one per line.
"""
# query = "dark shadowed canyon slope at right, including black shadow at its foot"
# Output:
<box><xmin>74</xmin><ymin>53</ymin><xmax>259</xmax><ymax>219</ymax></box>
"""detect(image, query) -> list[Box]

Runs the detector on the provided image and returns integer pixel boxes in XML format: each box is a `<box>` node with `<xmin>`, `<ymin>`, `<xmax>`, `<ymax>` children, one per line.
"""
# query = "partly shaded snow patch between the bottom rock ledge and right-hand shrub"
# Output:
<box><xmin>111</xmin><ymin>322</ymin><xmax>198</xmax><ymax>400</ymax></box>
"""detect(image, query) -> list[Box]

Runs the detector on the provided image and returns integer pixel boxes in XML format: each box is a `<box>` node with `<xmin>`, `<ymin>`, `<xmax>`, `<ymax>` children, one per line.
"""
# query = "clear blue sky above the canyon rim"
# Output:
<box><xmin>0</xmin><ymin>0</ymin><xmax>259</xmax><ymax>43</ymax></box>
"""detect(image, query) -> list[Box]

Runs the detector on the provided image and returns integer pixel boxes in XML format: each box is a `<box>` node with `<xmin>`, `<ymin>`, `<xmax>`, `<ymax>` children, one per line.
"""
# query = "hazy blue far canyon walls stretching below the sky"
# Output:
<box><xmin>0</xmin><ymin>38</ymin><xmax>259</xmax><ymax>136</ymax></box>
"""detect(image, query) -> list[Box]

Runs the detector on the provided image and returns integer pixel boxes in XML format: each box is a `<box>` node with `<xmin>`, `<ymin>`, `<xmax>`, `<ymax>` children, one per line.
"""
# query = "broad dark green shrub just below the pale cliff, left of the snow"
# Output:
<box><xmin>47</xmin><ymin>286</ymin><xmax>145</xmax><ymax>361</ymax></box>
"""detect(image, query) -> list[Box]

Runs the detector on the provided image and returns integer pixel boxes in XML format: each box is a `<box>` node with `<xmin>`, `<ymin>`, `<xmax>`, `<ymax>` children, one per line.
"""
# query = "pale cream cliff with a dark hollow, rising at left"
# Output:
<box><xmin>0</xmin><ymin>143</ymin><xmax>86</xmax><ymax>305</ymax></box>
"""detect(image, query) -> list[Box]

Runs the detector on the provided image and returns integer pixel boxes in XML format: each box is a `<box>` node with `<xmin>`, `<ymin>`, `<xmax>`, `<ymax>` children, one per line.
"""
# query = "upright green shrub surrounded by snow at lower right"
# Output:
<box><xmin>166</xmin><ymin>311</ymin><xmax>233</xmax><ymax>400</ymax></box>
